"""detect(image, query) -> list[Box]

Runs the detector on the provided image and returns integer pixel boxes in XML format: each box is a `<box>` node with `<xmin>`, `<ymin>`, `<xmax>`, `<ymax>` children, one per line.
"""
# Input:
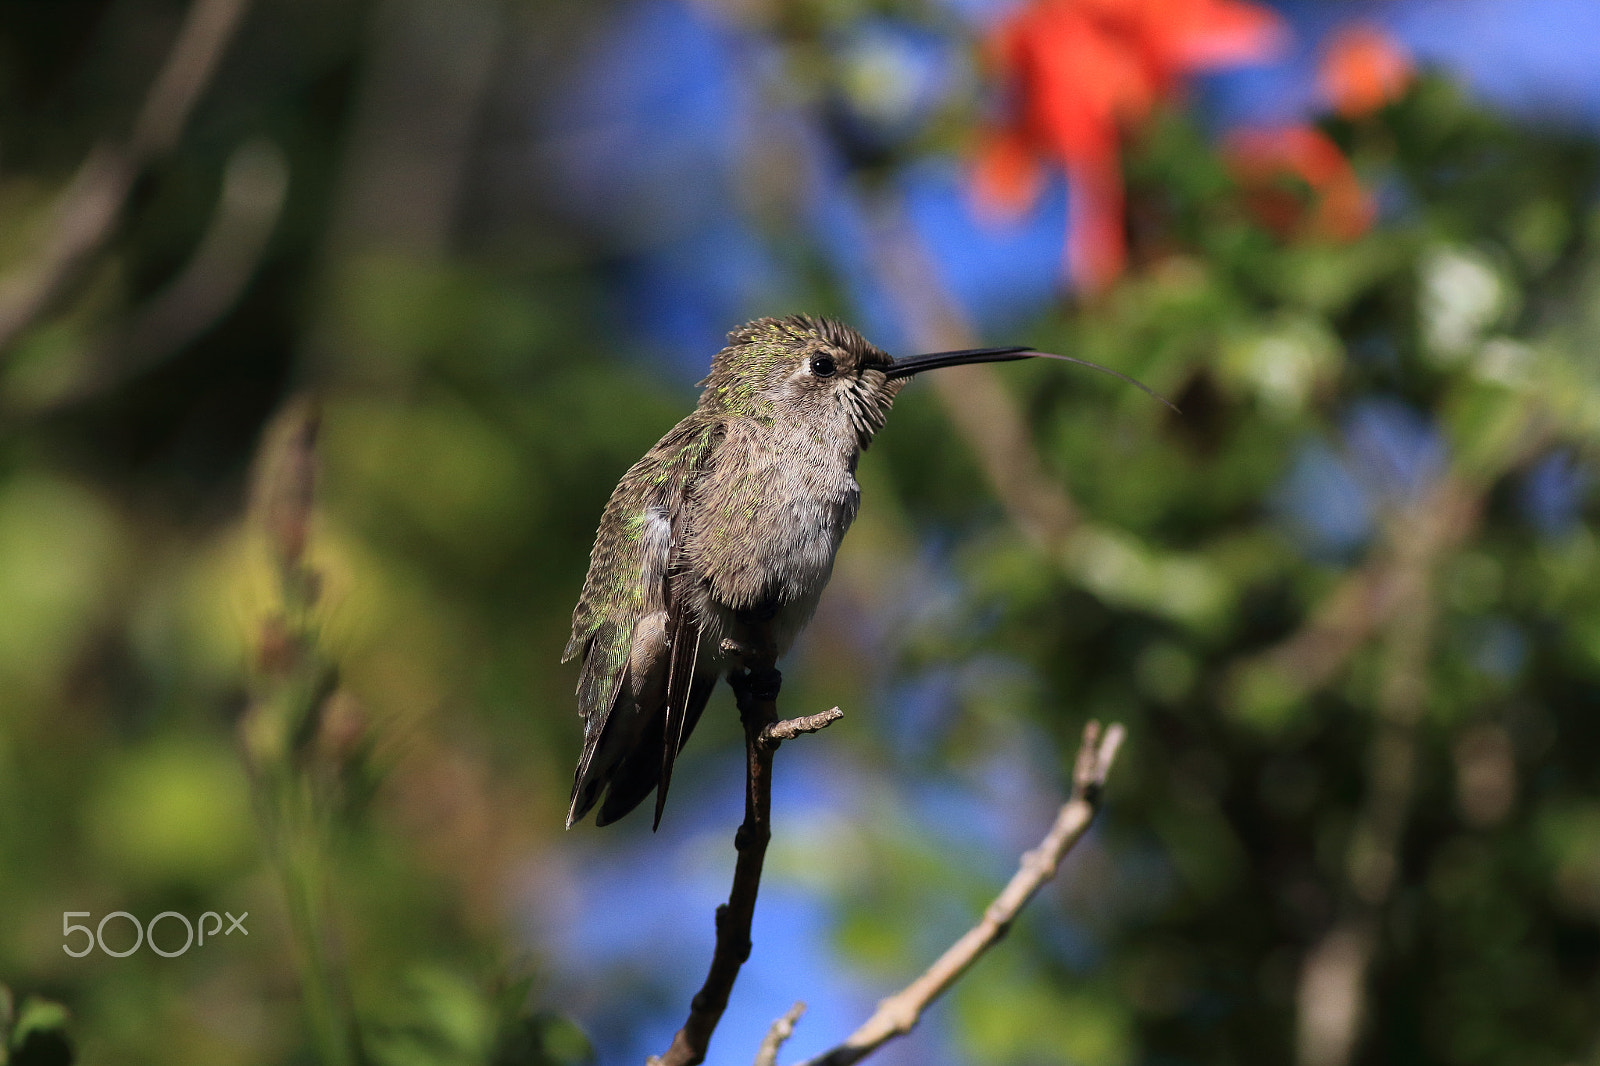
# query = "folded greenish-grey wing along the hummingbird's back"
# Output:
<box><xmin>562</xmin><ymin>419</ymin><xmax>718</xmax><ymax>826</ymax></box>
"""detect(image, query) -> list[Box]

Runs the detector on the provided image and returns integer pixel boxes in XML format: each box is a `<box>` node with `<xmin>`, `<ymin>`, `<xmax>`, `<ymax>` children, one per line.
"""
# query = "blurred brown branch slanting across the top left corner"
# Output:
<box><xmin>0</xmin><ymin>0</ymin><xmax>248</xmax><ymax>352</ymax></box>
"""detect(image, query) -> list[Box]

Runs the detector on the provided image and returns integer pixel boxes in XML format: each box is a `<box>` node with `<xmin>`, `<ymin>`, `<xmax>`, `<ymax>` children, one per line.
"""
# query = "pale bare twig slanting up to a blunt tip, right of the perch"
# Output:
<box><xmin>790</xmin><ymin>722</ymin><xmax>1123</xmax><ymax>1066</ymax></box>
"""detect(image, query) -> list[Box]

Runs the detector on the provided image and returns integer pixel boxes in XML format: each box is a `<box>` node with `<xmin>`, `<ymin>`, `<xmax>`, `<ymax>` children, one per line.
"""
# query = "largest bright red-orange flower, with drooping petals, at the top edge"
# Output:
<box><xmin>974</xmin><ymin>0</ymin><xmax>1285</xmax><ymax>290</ymax></box>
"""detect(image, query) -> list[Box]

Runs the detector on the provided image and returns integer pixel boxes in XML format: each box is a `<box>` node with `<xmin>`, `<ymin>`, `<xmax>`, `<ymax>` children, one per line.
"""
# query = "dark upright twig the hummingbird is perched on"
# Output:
<box><xmin>650</xmin><ymin>634</ymin><xmax>845</xmax><ymax>1066</ymax></box>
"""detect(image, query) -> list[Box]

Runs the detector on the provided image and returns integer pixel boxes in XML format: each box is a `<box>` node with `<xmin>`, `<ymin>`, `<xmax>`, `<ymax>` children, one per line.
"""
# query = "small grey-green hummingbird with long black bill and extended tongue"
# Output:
<box><xmin>562</xmin><ymin>315</ymin><xmax>1171</xmax><ymax>829</ymax></box>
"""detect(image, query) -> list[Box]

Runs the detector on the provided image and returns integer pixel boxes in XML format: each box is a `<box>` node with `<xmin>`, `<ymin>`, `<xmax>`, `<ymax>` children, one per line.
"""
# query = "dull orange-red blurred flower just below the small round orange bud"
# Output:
<box><xmin>1224</xmin><ymin>125</ymin><xmax>1374</xmax><ymax>240</ymax></box>
